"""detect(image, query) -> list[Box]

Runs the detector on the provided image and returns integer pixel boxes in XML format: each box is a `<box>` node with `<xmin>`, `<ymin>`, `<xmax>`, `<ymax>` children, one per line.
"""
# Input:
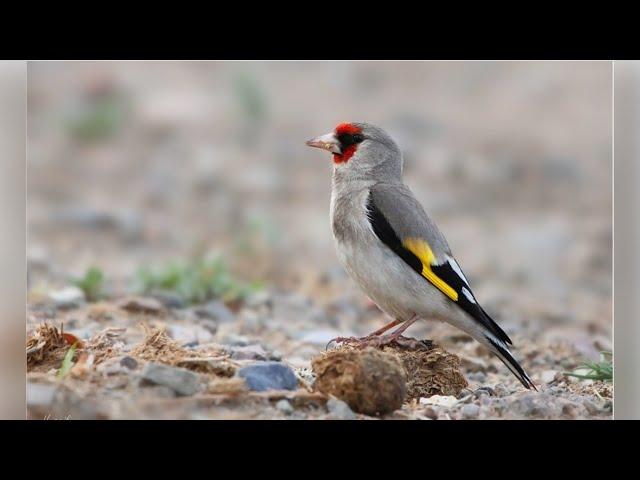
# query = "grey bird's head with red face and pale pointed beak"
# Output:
<box><xmin>306</xmin><ymin>122</ymin><xmax>402</xmax><ymax>181</ymax></box>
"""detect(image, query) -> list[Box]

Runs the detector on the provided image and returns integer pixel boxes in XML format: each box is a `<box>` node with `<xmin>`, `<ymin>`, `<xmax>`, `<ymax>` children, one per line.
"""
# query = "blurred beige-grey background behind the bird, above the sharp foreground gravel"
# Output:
<box><xmin>27</xmin><ymin>61</ymin><xmax>612</xmax><ymax>418</ymax></box>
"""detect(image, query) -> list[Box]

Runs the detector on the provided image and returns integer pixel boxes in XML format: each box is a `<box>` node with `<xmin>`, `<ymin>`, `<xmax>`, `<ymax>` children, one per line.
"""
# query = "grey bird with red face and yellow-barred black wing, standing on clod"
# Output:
<box><xmin>306</xmin><ymin>122</ymin><xmax>537</xmax><ymax>390</ymax></box>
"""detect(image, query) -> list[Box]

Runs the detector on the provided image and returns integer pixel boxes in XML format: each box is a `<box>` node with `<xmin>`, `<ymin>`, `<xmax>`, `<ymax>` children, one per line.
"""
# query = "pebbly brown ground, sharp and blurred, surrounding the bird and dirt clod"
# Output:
<box><xmin>27</xmin><ymin>62</ymin><xmax>612</xmax><ymax>419</ymax></box>
